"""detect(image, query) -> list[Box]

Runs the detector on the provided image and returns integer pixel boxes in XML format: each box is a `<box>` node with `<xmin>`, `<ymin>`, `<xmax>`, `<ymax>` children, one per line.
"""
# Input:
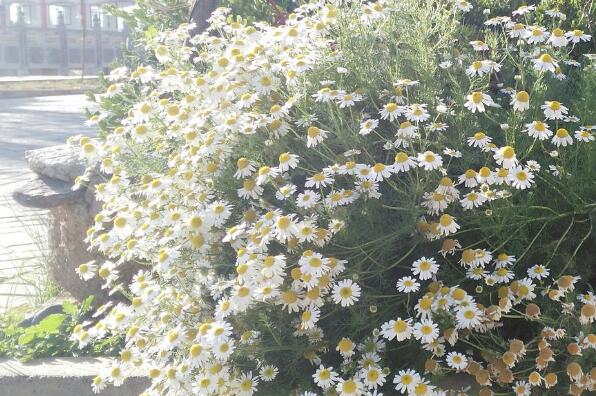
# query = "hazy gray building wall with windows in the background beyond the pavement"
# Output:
<box><xmin>0</xmin><ymin>0</ymin><xmax>131</xmax><ymax>76</ymax></box>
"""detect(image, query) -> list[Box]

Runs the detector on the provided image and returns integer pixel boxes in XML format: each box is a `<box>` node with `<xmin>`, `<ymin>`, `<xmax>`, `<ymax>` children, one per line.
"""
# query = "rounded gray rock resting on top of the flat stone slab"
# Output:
<box><xmin>25</xmin><ymin>144</ymin><xmax>85</xmax><ymax>183</ymax></box>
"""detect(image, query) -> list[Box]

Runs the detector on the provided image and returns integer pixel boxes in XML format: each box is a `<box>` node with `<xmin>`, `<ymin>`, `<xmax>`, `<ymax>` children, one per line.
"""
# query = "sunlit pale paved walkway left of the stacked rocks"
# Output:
<box><xmin>0</xmin><ymin>95</ymin><xmax>92</xmax><ymax>312</ymax></box>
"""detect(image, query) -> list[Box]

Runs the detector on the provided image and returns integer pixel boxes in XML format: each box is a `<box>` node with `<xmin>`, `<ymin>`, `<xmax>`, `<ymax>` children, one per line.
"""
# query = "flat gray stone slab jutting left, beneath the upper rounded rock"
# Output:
<box><xmin>12</xmin><ymin>176</ymin><xmax>84</xmax><ymax>209</ymax></box>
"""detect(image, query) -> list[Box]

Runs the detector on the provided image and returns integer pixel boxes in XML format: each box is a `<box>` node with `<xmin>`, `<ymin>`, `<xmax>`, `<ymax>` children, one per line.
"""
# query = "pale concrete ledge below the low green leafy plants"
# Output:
<box><xmin>0</xmin><ymin>358</ymin><xmax>150</xmax><ymax>396</ymax></box>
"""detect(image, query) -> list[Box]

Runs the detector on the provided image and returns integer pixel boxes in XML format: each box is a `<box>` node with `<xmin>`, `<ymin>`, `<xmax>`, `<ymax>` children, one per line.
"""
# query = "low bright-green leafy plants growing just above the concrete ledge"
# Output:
<box><xmin>0</xmin><ymin>296</ymin><xmax>122</xmax><ymax>361</ymax></box>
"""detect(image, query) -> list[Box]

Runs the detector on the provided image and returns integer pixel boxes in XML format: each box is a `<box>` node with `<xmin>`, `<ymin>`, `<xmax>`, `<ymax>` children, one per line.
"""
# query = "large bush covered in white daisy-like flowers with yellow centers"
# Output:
<box><xmin>73</xmin><ymin>0</ymin><xmax>596</xmax><ymax>396</ymax></box>
